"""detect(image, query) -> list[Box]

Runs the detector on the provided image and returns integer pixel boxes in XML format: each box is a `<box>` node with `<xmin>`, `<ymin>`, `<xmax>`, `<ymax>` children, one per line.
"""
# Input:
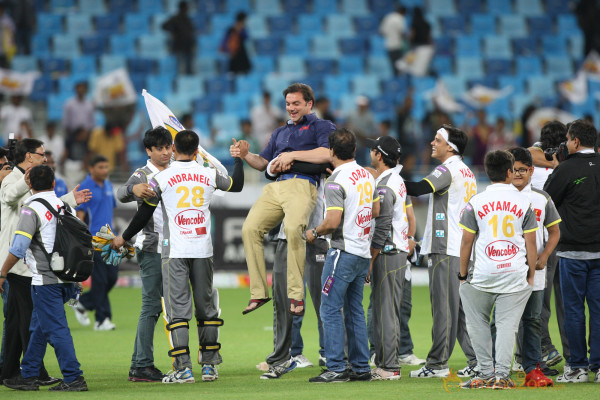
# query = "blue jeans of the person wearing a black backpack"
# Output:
<box><xmin>21</xmin><ymin>283</ymin><xmax>83</xmax><ymax>383</ymax></box>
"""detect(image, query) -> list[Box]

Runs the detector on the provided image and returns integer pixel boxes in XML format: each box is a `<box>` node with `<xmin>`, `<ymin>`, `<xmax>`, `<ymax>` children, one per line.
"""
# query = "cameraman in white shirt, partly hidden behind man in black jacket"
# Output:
<box><xmin>529</xmin><ymin>121</ymin><xmax>570</xmax><ymax>366</ymax></box>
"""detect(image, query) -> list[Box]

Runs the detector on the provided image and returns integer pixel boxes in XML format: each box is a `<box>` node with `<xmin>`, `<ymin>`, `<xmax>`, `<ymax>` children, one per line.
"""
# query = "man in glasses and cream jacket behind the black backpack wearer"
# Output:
<box><xmin>0</xmin><ymin>139</ymin><xmax>91</xmax><ymax>385</ymax></box>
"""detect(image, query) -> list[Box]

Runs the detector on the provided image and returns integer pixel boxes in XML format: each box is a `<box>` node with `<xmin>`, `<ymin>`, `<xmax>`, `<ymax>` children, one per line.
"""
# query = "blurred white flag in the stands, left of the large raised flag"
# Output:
<box><xmin>94</xmin><ymin>68</ymin><xmax>136</xmax><ymax>107</ymax></box>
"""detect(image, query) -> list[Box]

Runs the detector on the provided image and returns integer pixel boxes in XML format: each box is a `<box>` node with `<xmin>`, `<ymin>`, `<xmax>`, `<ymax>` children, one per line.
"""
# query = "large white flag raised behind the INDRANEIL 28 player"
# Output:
<box><xmin>142</xmin><ymin>89</ymin><xmax>229</xmax><ymax>181</ymax></box>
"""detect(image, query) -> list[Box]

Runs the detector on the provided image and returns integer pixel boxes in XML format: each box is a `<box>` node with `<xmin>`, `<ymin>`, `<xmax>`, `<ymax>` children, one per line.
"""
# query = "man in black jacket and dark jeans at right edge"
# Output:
<box><xmin>544</xmin><ymin>119</ymin><xmax>600</xmax><ymax>383</ymax></box>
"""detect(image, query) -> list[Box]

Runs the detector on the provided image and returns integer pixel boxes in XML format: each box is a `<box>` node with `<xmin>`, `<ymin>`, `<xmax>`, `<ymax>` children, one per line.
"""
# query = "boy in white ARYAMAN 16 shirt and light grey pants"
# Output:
<box><xmin>458</xmin><ymin>150</ymin><xmax>538</xmax><ymax>389</ymax></box>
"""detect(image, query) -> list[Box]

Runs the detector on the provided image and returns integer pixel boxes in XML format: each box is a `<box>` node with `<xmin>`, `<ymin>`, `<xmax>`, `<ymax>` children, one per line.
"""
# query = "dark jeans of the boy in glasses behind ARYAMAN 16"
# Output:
<box><xmin>517</xmin><ymin>290</ymin><xmax>544</xmax><ymax>373</ymax></box>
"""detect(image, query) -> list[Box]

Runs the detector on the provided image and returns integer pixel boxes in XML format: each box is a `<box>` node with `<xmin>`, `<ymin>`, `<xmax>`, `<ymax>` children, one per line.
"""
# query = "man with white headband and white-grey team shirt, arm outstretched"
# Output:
<box><xmin>405</xmin><ymin>125</ymin><xmax>477</xmax><ymax>378</ymax></box>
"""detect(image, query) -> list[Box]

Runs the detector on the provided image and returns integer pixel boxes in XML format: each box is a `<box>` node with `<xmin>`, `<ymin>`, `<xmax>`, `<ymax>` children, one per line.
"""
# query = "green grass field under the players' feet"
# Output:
<box><xmin>0</xmin><ymin>287</ymin><xmax>600</xmax><ymax>400</ymax></box>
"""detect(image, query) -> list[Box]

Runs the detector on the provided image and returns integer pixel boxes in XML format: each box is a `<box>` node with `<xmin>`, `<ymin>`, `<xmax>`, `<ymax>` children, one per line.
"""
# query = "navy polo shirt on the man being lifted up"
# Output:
<box><xmin>259</xmin><ymin>113</ymin><xmax>335</xmax><ymax>161</ymax></box>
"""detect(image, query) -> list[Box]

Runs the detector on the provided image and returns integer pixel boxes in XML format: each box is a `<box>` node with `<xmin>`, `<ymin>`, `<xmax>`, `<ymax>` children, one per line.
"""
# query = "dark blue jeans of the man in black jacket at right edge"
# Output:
<box><xmin>559</xmin><ymin>257</ymin><xmax>600</xmax><ymax>371</ymax></box>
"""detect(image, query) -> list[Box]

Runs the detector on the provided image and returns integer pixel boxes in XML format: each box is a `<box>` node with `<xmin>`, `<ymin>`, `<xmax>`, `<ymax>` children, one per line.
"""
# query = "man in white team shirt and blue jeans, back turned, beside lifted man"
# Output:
<box><xmin>305</xmin><ymin>128</ymin><xmax>379</xmax><ymax>383</ymax></box>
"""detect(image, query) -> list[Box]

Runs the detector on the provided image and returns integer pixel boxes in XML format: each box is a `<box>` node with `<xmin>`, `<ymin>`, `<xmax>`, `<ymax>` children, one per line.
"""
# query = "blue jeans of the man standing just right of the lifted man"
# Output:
<box><xmin>321</xmin><ymin>249</ymin><xmax>370</xmax><ymax>373</ymax></box>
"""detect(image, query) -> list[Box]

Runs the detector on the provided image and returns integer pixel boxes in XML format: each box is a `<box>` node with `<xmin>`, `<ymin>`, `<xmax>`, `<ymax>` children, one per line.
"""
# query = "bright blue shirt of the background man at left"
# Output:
<box><xmin>77</xmin><ymin>175</ymin><xmax>117</xmax><ymax>235</ymax></box>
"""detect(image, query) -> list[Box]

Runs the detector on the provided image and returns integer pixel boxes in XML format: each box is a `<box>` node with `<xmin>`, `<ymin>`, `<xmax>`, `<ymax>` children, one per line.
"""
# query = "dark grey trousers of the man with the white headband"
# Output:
<box><xmin>425</xmin><ymin>254</ymin><xmax>477</xmax><ymax>369</ymax></box>
